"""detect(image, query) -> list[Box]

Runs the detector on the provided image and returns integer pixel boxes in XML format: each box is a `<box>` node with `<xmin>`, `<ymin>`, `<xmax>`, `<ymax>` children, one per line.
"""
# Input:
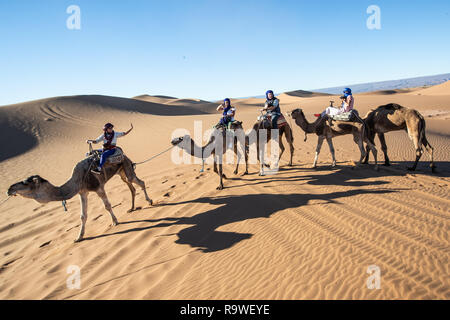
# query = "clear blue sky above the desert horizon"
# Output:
<box><xmin>0</xmin><ymin>0</ymin><xmax>450</xmax><ymax>105</ymax></box>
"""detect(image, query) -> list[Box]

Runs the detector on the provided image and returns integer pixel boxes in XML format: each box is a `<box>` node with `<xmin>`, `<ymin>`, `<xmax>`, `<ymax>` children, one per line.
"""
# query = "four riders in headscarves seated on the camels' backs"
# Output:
<box><xmin>86</xmin><ymin>88</ymin><xmax>355</xmax><ymax>174</ymax></box>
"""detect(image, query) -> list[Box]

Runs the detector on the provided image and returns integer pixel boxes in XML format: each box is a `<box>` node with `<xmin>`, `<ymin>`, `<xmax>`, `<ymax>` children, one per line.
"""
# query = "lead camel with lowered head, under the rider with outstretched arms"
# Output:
<box><xmin>7</xmin><ymin>155</ymin><xmax>152</xmax><ymax>242</ymax></box>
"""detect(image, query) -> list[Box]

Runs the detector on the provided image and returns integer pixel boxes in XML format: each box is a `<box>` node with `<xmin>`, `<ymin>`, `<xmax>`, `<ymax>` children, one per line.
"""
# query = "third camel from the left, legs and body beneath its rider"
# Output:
<box><xmin>246</xmin><ymin>114</ymin><xmax>294</xmax><ymax>176</ymax></box>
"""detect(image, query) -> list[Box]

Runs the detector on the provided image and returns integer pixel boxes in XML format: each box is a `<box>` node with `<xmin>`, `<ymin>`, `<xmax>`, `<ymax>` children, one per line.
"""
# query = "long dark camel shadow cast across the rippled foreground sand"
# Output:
<box><xmin>85</xmin><ymin>176</ymin><xmax>397</xmax><ymax>252</ymax></box>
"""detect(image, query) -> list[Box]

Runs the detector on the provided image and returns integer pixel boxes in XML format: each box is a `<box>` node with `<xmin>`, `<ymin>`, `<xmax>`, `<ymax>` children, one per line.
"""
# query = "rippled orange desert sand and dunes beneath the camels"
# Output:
<box><xmin>0</xmin><ymin>83</ymin><xmax>450</xmax><ymax>299</ymax></box>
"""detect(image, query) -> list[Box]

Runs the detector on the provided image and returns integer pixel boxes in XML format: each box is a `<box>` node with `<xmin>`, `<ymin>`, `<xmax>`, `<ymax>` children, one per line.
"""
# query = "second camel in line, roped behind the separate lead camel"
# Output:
<box><xmin>171</xmin><ymin>121</ymin><xmax>248</xmax><ymax>190</ymax></box>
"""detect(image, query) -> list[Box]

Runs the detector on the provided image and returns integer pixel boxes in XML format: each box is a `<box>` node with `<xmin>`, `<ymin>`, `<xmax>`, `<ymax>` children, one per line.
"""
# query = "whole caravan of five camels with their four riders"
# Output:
<box><xmin>7</xmin><ymin>88</ymin><xmax>435</xmax><ymax>242</ymax></box>
